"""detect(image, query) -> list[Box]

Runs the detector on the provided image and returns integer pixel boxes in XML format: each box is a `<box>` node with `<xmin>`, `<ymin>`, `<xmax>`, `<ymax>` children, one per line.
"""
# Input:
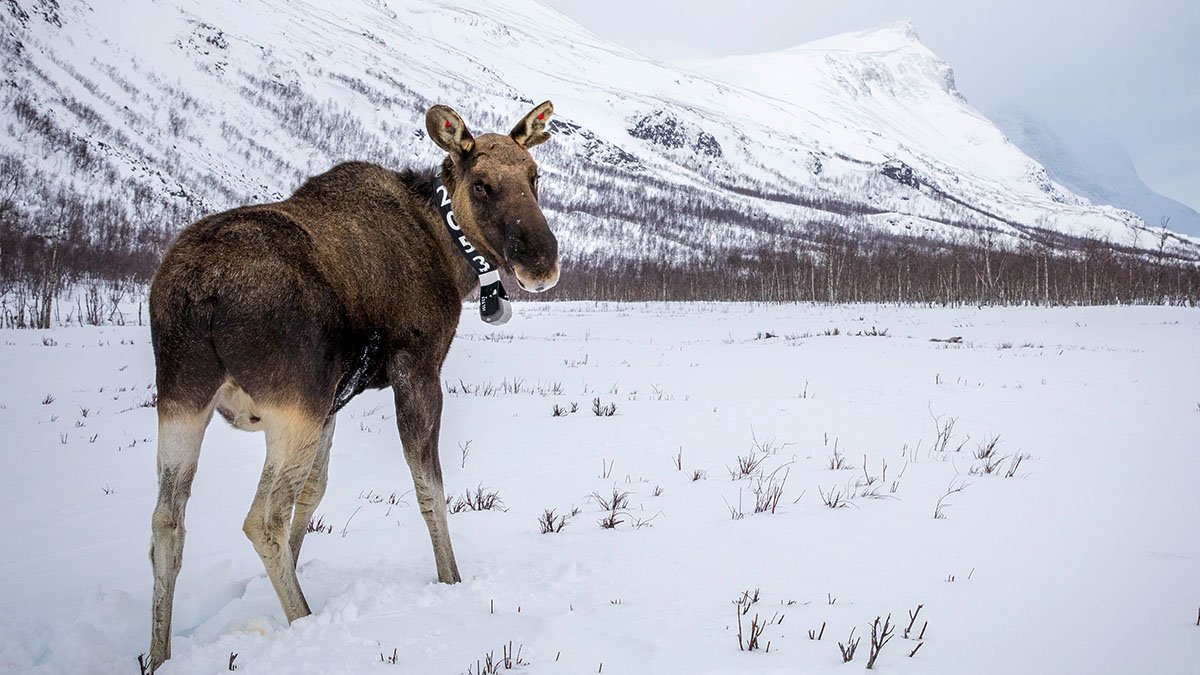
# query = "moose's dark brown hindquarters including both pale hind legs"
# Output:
<box><xmin>150</xmin><ymin>208</ymin><xmax>382</xmax><ymax>648</ymax></box>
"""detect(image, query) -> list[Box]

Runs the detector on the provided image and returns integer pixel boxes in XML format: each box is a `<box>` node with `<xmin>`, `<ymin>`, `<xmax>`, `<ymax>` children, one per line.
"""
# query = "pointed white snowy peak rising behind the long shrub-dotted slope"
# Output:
<box><xmin>685</xmin><ymin>22</ymin><xmax>1190</xmax><ymax>249</ymax></box>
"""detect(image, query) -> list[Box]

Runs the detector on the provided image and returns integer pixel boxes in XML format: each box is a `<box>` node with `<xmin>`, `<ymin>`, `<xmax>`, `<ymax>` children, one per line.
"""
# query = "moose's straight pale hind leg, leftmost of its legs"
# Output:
<box><xmin>150</xmin><ymin>401</ymin><xmax>212</xmax><ymax>671</ymax></box>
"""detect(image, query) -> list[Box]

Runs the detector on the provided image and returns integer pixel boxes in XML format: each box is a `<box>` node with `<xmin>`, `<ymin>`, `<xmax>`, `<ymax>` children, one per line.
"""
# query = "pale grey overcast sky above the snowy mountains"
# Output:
<box><xmin>545</xmin><ymin>0</ymin><xmax>1200</xmax><ymax>210</ymax></box>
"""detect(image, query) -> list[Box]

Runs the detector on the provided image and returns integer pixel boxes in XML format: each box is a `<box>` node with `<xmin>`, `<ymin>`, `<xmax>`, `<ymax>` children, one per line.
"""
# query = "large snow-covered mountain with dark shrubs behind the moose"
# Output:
<box><xmin>0</xmin><ymin>0</ymin><xmax>1200</xmax><ymax>267</ymax></box>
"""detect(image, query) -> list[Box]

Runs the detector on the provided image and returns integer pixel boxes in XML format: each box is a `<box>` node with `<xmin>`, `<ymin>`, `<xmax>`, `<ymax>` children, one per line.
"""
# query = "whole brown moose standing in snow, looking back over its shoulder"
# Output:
<box><xmin>149</xmin><ymin>101</ymin><xmax>559</xmax><ymax>671</ymax></box>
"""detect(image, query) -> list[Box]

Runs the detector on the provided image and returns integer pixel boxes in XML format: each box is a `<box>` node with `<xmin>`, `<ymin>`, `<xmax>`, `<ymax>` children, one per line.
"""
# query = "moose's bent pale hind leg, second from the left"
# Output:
<box><xmin>242</xmin><ymin>408</ymin><xmax>324</xmax><ymax>623</ymax></box>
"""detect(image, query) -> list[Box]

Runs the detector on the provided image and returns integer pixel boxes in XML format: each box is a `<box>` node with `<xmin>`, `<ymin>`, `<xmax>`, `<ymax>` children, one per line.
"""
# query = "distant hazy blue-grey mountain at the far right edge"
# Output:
<box><xmin>989</xmin><ymin>107</ymin><xmax>1200</xmax><ymax>237</ymax></box>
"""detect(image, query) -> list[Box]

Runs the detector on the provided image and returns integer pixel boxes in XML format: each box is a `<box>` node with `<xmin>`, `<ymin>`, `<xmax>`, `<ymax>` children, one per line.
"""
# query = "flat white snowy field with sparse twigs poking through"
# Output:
<box><xmin>0</xmin><ymin>304</ymin><xmax>1200</xmax><ymax>675</ymax></box>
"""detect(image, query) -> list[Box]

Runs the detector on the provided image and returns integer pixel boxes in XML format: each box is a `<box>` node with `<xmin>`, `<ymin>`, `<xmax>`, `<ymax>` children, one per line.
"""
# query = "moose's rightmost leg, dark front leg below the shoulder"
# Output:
<box><xmin>392</xmin><ymin>368</ymin><xmax>462</xmax><ymax>584</ymax></box>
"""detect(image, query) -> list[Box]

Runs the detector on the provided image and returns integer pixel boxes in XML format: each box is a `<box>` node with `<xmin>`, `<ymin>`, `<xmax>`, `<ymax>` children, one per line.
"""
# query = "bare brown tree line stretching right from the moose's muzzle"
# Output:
<box><xmin>546</xmin><ymin>227</ymin><xmax>1200</xmax><ymax>306</ymax></box>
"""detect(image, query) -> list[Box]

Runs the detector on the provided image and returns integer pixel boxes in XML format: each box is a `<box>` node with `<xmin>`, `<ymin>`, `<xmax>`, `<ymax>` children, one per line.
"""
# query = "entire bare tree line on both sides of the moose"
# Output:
<box><xmin>0</xmin><ymin>180</ymin><xmax>1200</xmax><ymax>327</ymax></box>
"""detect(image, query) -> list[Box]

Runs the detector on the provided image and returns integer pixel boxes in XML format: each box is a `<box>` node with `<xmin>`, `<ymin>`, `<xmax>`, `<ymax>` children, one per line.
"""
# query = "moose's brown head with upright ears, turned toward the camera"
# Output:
<box><xmin>425</xmin><ymin>101</ymin><xmax>558</xmax><ymax>293</ymax></box>
